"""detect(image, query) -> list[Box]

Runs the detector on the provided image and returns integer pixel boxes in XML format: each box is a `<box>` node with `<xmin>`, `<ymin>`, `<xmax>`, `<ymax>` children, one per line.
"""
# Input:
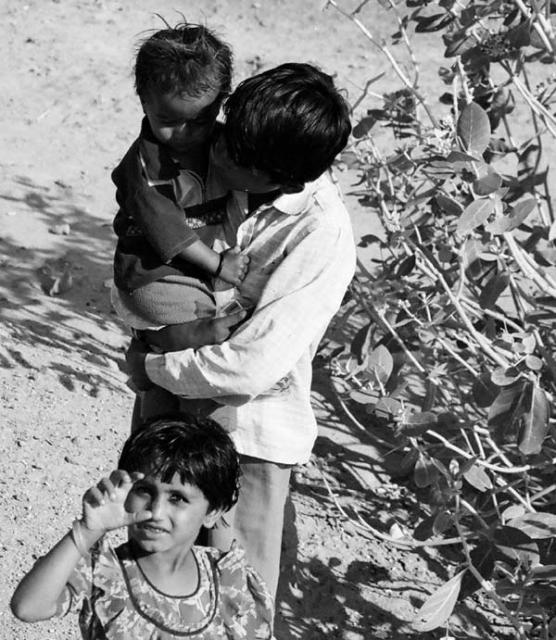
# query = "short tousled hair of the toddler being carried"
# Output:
<box><xmin>135</xmin><ymin>22</ymin><xmax>232</xmax><ymax>98</ymax></box>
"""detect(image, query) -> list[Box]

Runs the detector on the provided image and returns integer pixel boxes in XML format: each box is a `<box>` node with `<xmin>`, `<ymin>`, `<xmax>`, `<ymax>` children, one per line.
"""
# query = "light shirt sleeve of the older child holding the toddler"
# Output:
<box><xmin>145</xmin><ymin>218</ymin><xmax>355</xmax><ymax>405</ymax></box>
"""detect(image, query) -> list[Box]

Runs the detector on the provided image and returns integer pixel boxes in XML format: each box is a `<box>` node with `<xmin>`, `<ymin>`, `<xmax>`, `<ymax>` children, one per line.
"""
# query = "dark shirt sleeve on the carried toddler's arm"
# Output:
<box><xmin>112</xmin><ymin>145</ymin><xmax>199</xmax><ymax>263</ymax></box>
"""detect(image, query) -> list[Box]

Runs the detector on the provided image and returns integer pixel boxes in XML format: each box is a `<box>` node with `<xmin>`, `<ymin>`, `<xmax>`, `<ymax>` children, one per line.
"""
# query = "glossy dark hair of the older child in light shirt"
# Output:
<box><xmin>224</xmin><ymin>63</ymin><xmax>351</xmax><ymax>184</ymax></box>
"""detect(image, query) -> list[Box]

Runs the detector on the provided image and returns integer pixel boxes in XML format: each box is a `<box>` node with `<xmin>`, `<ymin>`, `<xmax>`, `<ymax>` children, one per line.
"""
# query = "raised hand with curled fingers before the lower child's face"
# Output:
<box><xmin>82</xmin><ymin>469</ymin><xmax>152</xmax><ymax>533</ymax></box>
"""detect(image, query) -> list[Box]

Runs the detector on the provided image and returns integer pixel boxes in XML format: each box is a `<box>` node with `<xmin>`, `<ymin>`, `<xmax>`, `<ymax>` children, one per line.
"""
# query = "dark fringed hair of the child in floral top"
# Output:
<box><xmin>118</xmin><ymin>414</ymin><xmax>240</xmax><ymax>511</ymax></box>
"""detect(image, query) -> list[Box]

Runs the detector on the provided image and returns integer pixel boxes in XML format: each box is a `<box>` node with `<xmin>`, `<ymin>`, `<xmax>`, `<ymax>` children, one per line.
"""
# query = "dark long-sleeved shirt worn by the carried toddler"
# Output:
<box><xmin>112</xmin><ymin>118</ymin><xmax>227</xmax><ymax>292</ymax></box>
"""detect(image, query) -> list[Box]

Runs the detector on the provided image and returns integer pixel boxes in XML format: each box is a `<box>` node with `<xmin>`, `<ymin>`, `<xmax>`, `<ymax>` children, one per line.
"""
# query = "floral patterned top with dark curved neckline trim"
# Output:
<box><xmin>57</xmin><ymin>539</ymin><xmax>273</xmax><ymax>640</ymax></box>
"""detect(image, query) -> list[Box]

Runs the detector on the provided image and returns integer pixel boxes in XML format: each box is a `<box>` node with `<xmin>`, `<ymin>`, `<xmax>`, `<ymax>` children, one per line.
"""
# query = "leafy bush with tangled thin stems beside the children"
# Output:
<box><xmin>328</xmin><ymin>0</ymin><xmax>556</xmax><ymax>638</ymax></box>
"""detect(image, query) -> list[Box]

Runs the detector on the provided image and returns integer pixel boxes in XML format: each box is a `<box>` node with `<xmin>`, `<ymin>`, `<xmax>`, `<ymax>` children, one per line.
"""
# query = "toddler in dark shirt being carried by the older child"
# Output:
<box><xmin>112</xmin><ymin>23</ymin><xmax>248</xmax><ymax>329</ymax></box>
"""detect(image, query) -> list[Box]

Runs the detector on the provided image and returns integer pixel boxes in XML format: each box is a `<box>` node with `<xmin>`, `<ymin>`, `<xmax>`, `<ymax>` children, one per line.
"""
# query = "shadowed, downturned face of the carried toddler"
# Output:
<box><xmin>141</xmin><ymin>89</ymin><xmax>221</xmax><ymax>154</ymax></box>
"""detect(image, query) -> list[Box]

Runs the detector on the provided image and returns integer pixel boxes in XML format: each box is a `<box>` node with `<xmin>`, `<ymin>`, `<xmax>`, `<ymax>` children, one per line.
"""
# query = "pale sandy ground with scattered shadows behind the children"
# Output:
<box><xmin>0</xmin><ymin>0</ymin><xmax>516</xmax><ymax>640</ymax></box>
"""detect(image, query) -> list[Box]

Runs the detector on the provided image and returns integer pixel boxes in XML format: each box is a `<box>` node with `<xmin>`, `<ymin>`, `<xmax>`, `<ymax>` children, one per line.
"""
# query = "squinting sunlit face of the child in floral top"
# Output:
<box><xmin>125</xmin><ymin>474</ymin><xmax>220</xmax><ymax>553</ymax></box>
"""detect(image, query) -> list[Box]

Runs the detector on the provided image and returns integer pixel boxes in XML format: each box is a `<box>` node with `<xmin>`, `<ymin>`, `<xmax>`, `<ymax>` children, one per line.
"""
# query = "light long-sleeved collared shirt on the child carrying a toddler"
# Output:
<box><xmin>145</xmin><ymin>175</ymin><xmax>355</xmax><ymax>464</ymax></box>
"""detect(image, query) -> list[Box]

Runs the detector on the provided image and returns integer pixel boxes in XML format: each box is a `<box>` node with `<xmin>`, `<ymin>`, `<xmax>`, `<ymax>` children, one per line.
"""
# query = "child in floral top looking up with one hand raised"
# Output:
<box><xmin>11</xmin><ymin>415</ymin><xmax>273</xmax><ymax>640</ymax></box>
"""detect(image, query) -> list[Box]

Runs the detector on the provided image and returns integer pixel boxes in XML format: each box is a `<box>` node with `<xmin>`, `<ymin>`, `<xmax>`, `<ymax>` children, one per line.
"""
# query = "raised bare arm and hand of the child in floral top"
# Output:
<box><xmin>10</xmin><ymin>470</ymin><xmax>151</xmax><ymax>622</ymax></box>
